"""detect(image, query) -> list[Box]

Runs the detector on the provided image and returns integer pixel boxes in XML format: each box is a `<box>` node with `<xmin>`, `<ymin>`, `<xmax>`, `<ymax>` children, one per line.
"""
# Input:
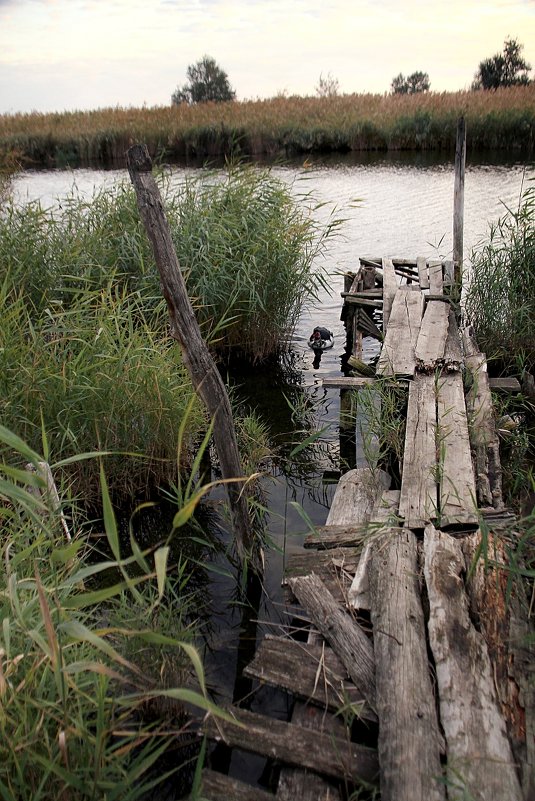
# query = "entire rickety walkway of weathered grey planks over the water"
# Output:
<box><xmin>202</xmin><ymin>258</ymin><xmax>535</xmax><ymax>801</ymax></box>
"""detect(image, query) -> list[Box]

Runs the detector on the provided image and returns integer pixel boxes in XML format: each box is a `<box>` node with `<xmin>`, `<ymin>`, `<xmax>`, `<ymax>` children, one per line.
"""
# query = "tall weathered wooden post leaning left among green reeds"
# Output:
<box><xmin>126</xmin><ymin>145</ymin><xmax>255</xmax><ymax>563</ymax></box>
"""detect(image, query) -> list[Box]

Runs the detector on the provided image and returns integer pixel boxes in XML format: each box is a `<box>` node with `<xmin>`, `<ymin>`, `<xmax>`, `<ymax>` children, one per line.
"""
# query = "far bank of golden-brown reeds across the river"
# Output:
<box><xmin>0</xmin><ymin>84</ymin><xmax>535</xmax><ymax>166</ymax></box>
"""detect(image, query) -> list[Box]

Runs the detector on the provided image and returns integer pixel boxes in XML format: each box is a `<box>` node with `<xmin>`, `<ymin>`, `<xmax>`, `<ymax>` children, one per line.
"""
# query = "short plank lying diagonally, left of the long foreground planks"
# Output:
<box><xmin>288</xmin><ymin>573</ymin><xmax>375</xmax><ymax>709</ymax></box>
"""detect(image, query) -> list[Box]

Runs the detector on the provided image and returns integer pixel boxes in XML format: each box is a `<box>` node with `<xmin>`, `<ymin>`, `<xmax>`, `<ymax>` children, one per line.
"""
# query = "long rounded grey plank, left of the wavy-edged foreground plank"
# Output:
<box><xmin>369</xmin><ymin>528</ymin><xmax>445</xmax><ymax>801</ymax></box>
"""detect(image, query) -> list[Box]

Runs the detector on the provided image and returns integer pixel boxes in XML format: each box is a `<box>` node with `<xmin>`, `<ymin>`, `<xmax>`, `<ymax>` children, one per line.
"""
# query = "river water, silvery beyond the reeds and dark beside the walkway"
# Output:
<box><xmin>14</xmin><ymin>154</ymin><xmax>535</xmax><ymax>792</ymax></box>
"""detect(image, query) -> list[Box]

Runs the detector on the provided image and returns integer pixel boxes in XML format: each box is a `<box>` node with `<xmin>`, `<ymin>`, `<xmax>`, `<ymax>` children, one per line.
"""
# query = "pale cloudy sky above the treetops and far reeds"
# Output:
<box><xmin>0</xmin><ymin>0</ymin><xmax>535</xmax><ymax>113</ymax></box>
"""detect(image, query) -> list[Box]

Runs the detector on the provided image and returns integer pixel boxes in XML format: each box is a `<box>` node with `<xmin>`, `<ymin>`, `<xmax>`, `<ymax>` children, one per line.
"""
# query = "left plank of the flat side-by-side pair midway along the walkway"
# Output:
<box><xmin>399</xmin><ymin>375</ymin><xmax>438</xmax><ymax>529</ymax></box>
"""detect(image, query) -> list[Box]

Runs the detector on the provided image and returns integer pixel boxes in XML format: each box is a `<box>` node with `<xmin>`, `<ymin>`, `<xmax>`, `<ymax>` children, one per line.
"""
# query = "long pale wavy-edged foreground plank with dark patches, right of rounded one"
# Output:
<box><xmin>424</xmin><ymin>526</ymin><xmax>522</xmax><ymax>801</ymax></box>
